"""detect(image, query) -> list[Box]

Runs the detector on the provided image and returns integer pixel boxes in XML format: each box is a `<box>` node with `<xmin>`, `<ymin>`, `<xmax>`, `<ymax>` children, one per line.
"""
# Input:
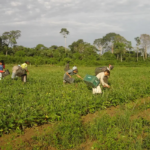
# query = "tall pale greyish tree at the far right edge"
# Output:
<box><xmin>140</xmin><ymin>34</ymin><xmax>150</xmax><ymax>59</ymax></box>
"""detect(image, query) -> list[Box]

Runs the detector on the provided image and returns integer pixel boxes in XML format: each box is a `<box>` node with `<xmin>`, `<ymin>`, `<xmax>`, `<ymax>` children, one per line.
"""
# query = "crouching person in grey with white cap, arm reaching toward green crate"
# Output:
<box><xmin>63</xmin><ymin>66</ymin><xmax>82</xmax><ymax>83</ymax></box>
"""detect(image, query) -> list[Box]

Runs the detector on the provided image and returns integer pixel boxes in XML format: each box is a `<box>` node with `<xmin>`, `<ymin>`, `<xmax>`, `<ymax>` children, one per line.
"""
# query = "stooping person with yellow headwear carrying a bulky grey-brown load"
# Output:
<box><xmin>11</xmin><ymin>61</ymin><xmax>29</xmax><ymax>82</ymax></box>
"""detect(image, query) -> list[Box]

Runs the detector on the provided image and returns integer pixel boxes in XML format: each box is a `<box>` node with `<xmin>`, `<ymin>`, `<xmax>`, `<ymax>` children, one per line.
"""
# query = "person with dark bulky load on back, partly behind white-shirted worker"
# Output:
<box><xmin>95</xmin><ymin>65</ymin><xmax>114</xmax><ymax>84</ymax></box>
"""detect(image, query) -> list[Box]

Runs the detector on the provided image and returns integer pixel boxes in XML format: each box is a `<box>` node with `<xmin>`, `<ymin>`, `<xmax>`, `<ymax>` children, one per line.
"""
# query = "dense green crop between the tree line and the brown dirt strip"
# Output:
<box><xmin>0</xmin><ymin>66</ymin><xmax>150</xmax><ymax>132</ymax></box>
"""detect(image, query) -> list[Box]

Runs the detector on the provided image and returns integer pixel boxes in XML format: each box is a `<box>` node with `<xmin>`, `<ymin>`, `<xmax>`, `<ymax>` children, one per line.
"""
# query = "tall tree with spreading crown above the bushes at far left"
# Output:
<box><xmin>1</xmin><ymin>30</ymin><xmax>21</xmax><ymax>56</ymax></box>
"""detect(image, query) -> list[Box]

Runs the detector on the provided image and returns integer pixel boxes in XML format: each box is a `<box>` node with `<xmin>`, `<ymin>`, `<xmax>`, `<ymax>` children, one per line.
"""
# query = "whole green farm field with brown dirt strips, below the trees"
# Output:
<box><xmin>0</xmin><ymin>65</ymin><xmax>150</xmax><ymax>150</ymax></box>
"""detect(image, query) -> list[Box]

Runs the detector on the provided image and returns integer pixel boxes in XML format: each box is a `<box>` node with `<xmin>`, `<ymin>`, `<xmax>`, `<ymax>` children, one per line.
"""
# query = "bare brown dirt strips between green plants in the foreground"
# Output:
<box><xmin>0</xmin><ymin>97</ymin><xmax>150</xmax><ymax>150</ymax></box>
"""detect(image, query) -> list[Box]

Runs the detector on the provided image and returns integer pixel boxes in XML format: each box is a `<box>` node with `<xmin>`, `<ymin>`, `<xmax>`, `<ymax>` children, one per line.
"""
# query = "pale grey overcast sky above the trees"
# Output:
<box><xmin>0</xmin><ymin>0</ymin><xmax>150</xmax><ymax>47</ymax></box>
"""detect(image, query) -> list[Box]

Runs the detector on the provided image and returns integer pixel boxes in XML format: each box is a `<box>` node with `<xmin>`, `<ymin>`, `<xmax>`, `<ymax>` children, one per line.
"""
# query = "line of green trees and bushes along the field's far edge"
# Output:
<box><xmin>0</xmin><ymin>28</ymin><xmax>150</xmax><ymax>64</ymax></box>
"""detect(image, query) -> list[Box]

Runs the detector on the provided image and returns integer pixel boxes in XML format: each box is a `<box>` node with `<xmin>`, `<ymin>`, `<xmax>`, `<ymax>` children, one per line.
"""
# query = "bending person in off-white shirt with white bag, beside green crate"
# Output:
<box><xmin>92</xmin><ymin>70</ymin><xmax>110</xmax><ymax>94</ymax></box>
